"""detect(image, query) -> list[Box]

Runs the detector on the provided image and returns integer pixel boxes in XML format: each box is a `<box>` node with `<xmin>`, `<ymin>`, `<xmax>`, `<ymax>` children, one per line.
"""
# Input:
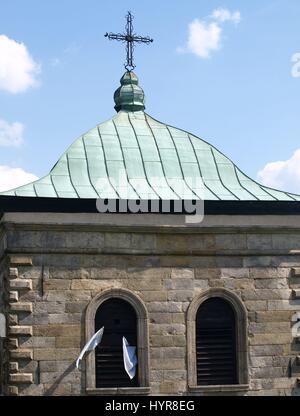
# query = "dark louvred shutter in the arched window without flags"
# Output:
<box><xmin>196</xmin><ymin>297</ymin><xmax>237</xmax><ymax>385</ymax></box>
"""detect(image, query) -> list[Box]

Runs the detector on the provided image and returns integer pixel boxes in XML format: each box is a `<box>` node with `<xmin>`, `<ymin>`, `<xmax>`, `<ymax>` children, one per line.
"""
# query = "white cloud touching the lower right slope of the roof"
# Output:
<box><xmin>257</xmin><ymin>149</ymin><xmax>300</xmax><ymax>193</ymax></box>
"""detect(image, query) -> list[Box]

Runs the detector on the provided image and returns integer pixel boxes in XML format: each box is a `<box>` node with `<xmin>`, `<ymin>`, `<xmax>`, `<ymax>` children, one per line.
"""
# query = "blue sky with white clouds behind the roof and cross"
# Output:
<box><xmin>0</xmin><ymin>0</ymin><xmax>300</xmax><ymax>192</ymax></box>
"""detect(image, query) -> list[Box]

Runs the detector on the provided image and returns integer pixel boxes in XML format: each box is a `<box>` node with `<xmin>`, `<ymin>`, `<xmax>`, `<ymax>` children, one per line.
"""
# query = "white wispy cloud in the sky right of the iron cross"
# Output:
<box><xmin>177</xmin><ymin>8</ymin><xmax>241</xmax><ymax>59</ymax></box>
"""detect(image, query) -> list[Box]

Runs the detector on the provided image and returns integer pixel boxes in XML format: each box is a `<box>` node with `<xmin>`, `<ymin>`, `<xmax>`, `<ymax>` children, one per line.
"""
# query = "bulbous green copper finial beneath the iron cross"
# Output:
<box><xmin>114</xmin><ymin>71</ymin><xmax>145</xmax><ymax>112</ymax></box>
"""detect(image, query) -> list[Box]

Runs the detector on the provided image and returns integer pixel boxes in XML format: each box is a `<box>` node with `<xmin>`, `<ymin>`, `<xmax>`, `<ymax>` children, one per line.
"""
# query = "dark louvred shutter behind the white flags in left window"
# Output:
<box><xmin>95</xmin><ymin>298</ymin><xmax>138</xmax><ymax>387</ymax></box>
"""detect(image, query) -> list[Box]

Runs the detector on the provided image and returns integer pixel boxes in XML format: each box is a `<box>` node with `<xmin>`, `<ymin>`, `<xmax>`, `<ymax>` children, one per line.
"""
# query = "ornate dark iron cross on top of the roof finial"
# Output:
<box><xmin>104</xmin><ymin>12</ymin><xmax>153</xmax><ymax>71</ymax></box>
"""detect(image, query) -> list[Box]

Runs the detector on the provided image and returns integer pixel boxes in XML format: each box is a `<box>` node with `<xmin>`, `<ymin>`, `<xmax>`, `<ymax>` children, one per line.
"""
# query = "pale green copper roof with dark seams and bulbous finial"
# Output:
<box><xmin>1</xmin><ymin>73</ymin><xmax>300</xmax><ymax>201</ymax></box>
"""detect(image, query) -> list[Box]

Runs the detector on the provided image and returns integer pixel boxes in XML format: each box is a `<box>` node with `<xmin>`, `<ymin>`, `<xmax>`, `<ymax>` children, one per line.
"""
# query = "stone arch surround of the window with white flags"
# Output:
<box><xmin>84</xmin><ymin>289</ymin><xmax>150</xmax><ymax>395</ymax></box>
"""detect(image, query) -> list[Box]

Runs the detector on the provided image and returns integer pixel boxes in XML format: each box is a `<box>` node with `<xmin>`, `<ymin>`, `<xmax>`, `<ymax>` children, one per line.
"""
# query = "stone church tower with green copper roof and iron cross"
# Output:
<box><xmin>0</xmin><ymin>13</ymin><xmax>300</xmax><ymax>396</ymax></box>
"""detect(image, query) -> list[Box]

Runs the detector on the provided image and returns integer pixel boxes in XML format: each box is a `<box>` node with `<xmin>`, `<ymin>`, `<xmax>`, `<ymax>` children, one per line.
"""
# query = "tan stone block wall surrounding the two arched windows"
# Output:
<box><xmin>0</xmin><ymin>219</ymin><xmax>300</xmax><ymax>395</ymax></box>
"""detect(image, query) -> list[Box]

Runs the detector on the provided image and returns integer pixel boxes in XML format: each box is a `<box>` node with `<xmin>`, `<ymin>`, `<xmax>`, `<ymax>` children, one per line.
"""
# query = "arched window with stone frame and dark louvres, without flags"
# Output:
<box><xmin>187</xmin><ymin>288</ymin><xmax>249</xmax><ymax>392</ymax></box>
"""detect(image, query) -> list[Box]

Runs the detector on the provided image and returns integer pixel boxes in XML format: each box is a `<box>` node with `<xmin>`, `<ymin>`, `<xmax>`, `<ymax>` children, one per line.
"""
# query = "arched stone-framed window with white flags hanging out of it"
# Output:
<box><xmin>82</xmin><ymin>289</ymin><xmax>150</xmax><ymax>395</ymax></box>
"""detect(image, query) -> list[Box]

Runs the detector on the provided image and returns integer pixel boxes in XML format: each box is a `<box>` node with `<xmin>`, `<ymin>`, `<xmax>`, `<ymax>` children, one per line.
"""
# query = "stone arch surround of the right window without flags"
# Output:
<box><xmin>187</xmin><ymin>288</ymin><xmax>249</xmax><ymax>392</ymax></box>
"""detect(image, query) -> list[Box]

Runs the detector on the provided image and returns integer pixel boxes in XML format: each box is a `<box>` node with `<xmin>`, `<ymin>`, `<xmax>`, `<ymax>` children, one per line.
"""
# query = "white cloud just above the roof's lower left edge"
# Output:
<box><xmin>0</xmin><ymin>166</ymin><xmax>38</xmax><ymax>192</ymax></box>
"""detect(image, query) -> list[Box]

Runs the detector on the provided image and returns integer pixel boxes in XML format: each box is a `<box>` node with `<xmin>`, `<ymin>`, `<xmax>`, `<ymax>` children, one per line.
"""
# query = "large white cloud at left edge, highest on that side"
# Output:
<box><xmin>0</xmin><ymin>35</ymin><xmax>40</xmax><ymax>94</ymax></box>
